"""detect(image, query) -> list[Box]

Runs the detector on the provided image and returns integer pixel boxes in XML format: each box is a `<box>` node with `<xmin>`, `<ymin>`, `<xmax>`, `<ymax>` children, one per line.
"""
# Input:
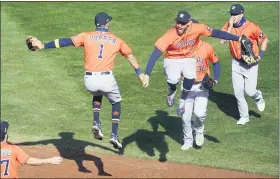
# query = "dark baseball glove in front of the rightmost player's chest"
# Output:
<box><xmin>241</xmin><ymin>35</ymin><xmax>257</xmax><ymax>65</ymax></box>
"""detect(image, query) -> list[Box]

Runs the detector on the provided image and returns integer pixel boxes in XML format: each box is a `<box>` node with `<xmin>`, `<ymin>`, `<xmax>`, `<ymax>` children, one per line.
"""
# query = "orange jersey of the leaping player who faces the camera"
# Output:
<box><xmin>155</xmin><ymin>23</ymin><xmax>213</xmax><ymax>59</ymax></box>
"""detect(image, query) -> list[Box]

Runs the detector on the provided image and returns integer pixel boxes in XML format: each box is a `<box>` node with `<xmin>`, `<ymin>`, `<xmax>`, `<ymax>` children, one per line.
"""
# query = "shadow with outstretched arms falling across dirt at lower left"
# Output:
<box><xmin>16</xmin><ymin>132</ymin><xmax>117</xmax><ymax>176</ymax></box>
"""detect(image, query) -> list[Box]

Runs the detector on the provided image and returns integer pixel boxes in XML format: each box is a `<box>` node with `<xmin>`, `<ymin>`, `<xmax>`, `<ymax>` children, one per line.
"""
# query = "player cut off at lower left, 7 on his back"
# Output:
<box><xmin>0</xmin><ymin>121</ymin><xmax>62</xmax><ymax>178</ymax></box>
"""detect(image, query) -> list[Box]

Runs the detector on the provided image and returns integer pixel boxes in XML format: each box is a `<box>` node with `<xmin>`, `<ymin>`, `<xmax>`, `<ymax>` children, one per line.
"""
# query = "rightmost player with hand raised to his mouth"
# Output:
<box><xmin>220</xmin><ymin>4</ymin><xmax>268</xmax><ymax>125</ymax></box>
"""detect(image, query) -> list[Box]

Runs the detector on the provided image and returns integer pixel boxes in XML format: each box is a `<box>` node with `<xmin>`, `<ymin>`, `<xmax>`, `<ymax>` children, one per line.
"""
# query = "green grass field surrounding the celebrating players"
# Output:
<box><xmin>1</xmin><ymin>2</ymin><xmax>279</xmax><ymax>176</ymax></box>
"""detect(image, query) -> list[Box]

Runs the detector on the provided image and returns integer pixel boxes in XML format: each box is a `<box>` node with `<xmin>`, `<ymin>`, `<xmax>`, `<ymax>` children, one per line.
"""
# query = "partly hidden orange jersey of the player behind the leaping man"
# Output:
<box><xmin>194</xmin><ymin>40</ymin><xmax>219</xmax><ymax>82</ymax></box>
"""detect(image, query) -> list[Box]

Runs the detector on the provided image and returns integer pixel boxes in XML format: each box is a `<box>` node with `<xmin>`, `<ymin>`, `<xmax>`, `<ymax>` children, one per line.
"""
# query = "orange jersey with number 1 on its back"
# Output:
<box><xmin>71</xmin><ymin>31</ymin><xmax>132</xmax><ymax>72</ymax></box>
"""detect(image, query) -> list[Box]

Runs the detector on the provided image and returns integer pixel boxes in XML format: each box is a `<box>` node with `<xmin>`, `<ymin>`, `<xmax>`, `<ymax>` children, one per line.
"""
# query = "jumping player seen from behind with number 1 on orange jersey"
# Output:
<box><xmin>29</xmin><ymin>12</ymin><xmax>144</xmax><ymax>149</ymax></box>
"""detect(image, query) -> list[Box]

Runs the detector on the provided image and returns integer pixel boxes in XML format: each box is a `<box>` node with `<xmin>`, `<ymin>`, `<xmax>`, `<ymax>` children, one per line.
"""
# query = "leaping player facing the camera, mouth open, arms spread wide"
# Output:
<box><xmin>143</xmin><ymin>11</ymin><xmax>241</xmax><ymax>107</ymax></box>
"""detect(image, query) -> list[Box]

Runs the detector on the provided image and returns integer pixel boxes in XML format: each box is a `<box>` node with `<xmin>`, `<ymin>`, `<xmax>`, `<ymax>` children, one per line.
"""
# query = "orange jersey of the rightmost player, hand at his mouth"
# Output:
<box><xmin>222</xmin><ymin>20</ymin><xmax>266</xmax><ymax>60</ymax></box>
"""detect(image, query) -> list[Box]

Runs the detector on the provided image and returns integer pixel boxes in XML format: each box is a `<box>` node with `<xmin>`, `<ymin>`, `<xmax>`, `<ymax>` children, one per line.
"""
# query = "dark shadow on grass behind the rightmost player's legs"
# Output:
<box><xmin>208</xmin><ymin>89</ymin><xmax>261</xmax><ymax>120</ymax></box>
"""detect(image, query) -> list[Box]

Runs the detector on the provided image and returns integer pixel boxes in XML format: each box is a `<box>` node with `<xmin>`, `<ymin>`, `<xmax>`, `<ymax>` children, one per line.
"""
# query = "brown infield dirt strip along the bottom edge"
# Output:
<box><xmin>19</xmin><ymin>145</ymin><xmax>275</xmax><ymax>178</ymax></box>
